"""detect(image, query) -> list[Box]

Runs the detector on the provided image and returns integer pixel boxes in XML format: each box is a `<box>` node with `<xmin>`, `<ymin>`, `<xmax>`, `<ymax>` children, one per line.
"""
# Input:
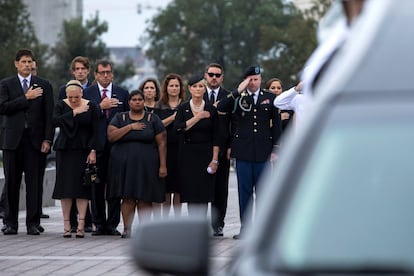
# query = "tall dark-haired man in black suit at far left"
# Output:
<box><xmin>0</xmin><ymin>49</ymin><xmax>54</xmax><ymax>235</ymax></box>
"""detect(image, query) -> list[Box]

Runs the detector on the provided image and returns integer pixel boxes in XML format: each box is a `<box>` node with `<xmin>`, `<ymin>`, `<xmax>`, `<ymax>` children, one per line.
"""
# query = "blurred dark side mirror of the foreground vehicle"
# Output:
<box><xmin>132</xmin><ymin>217</ymin><xmax>210</xmax><ymax>275</ymax></box>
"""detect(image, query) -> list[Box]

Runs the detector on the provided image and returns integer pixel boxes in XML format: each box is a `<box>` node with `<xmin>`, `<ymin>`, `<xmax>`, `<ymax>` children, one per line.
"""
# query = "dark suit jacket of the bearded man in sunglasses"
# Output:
<box><xmin>203</xmin><ymin>87</ymin><xmax>232</xmax><ymax>157</ymax></box>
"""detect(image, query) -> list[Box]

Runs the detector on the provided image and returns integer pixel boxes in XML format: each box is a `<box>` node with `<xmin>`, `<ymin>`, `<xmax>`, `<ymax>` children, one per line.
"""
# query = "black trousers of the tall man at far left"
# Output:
<box><xmin>3</xmin><ymin>130</ymin><xmax>46</xmax><ymax>229</ymax></box>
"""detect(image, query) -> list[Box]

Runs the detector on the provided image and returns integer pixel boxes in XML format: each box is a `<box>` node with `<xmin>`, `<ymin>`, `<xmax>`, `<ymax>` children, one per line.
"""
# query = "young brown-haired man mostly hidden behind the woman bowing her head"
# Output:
<box><xmin>58</xmin><ymin>56</ymin><xmax>92</xmax><ymax>233</ymax></box>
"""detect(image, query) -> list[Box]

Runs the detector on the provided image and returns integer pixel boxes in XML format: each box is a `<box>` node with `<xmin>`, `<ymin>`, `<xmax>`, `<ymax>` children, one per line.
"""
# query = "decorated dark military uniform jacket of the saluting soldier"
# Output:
<box><xmin>218</xmin><ymin>90</ymin><xmax>281</xmax><ymax>162</ymax></box>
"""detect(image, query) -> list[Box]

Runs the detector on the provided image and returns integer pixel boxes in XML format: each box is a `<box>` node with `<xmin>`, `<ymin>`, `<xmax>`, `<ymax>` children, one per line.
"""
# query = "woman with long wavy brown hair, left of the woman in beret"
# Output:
<box><xmin>154</xmin><ymin>73</ymin><xmax>185</xmax><ymax>217</ymax></box>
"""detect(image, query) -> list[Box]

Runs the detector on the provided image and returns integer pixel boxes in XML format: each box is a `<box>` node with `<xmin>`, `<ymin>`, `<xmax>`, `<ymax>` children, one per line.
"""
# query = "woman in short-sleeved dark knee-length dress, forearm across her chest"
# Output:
<box><xmin>108</xmin><ymin>90</ymin><xmax>167</xmax><ymax>238</ymax></box>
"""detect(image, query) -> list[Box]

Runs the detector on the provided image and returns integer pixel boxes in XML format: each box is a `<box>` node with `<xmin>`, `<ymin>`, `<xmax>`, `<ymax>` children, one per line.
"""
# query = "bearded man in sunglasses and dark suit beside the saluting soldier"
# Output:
<box><xmin>204</xmin><ymin>63</ymin><xmax>231</xmax><ymax>237</ymax></box>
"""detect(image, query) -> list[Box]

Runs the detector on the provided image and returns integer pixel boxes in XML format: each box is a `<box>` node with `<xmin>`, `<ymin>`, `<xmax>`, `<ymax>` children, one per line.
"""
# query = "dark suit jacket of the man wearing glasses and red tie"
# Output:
<box><xmin>83</xmin><ymin>84</ymin><xmax>129</xmax><ymax>151</ymax></box>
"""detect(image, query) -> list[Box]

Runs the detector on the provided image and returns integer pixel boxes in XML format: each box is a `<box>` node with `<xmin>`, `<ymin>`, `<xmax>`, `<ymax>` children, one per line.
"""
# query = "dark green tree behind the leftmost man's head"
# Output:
<box><xmin>0</xmin><ymin>0</ymin><xmax>47</xmax><ymax>79</ymax></box>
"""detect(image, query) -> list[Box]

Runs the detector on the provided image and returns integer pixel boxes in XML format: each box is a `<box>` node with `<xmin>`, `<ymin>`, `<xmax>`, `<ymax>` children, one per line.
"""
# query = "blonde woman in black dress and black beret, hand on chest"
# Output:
<box><xmin>174</xmin><ymin>75</ymin><xmax>219</xmax><ymax>215</ymax></box>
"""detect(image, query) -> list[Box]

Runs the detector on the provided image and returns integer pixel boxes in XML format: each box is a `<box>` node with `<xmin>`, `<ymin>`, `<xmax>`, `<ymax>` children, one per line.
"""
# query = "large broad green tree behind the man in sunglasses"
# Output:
<box><xmin>146</xmin><ymin>0</ymin><xmax>315</xmax><ymax>87</ymax></box>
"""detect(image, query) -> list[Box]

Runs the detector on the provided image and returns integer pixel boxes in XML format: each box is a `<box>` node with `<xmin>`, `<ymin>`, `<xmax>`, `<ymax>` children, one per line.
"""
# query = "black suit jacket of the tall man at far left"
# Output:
<box><xmin>0</xmin><ymin>75</ymin><xmax>54</xmax><ymax>150</ymax></box>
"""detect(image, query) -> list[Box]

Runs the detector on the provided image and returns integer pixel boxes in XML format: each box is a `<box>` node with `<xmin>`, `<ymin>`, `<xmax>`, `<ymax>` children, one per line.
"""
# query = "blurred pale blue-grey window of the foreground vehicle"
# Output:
<box><xmin>274</xmin><ymin>99</ymin><xmax>414</xmax><ymax>269</ymax></box>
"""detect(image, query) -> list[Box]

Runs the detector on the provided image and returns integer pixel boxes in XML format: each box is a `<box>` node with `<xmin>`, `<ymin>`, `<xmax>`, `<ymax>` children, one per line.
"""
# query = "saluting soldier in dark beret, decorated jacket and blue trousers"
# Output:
<box><xmin>218</xmin><ymin>66</ymin><xmax>282</xmax><ymax>239</ymax></box>
